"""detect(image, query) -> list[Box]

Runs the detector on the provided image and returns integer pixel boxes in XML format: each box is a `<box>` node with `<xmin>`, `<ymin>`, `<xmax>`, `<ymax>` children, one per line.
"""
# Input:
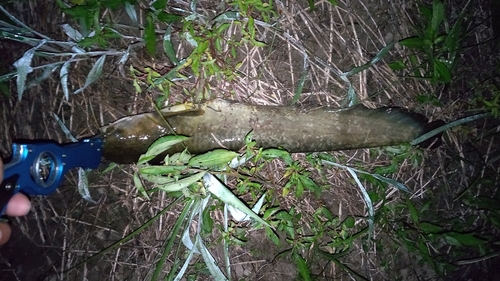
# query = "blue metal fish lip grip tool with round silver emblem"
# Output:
<box><xmin>0</xmin><ymin>136</ymin><xmax>102</xmax><ymax>214</ymax></box>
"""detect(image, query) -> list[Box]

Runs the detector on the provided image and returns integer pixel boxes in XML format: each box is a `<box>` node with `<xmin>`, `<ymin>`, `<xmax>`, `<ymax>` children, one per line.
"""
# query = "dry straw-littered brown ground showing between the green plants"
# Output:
<box><xmin>0</xmin><ymin>0</ymin><xmax>500</xmax><ymax>280</ymax></box>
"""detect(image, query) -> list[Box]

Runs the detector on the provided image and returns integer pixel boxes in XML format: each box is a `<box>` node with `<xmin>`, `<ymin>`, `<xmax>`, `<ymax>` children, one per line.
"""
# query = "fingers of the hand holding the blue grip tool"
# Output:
<box><xmin>0</xmin><ymin>158</ymin><xmax>31</xmax><ymax>245</ymax></box>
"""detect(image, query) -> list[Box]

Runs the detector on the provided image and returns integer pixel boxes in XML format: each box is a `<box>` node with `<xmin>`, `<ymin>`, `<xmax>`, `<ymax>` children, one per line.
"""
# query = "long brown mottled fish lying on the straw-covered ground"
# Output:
<box><xmin>101</xmin><ymin>99</ymin><xmax>427</xmax><ymax>163</ymax></box>
